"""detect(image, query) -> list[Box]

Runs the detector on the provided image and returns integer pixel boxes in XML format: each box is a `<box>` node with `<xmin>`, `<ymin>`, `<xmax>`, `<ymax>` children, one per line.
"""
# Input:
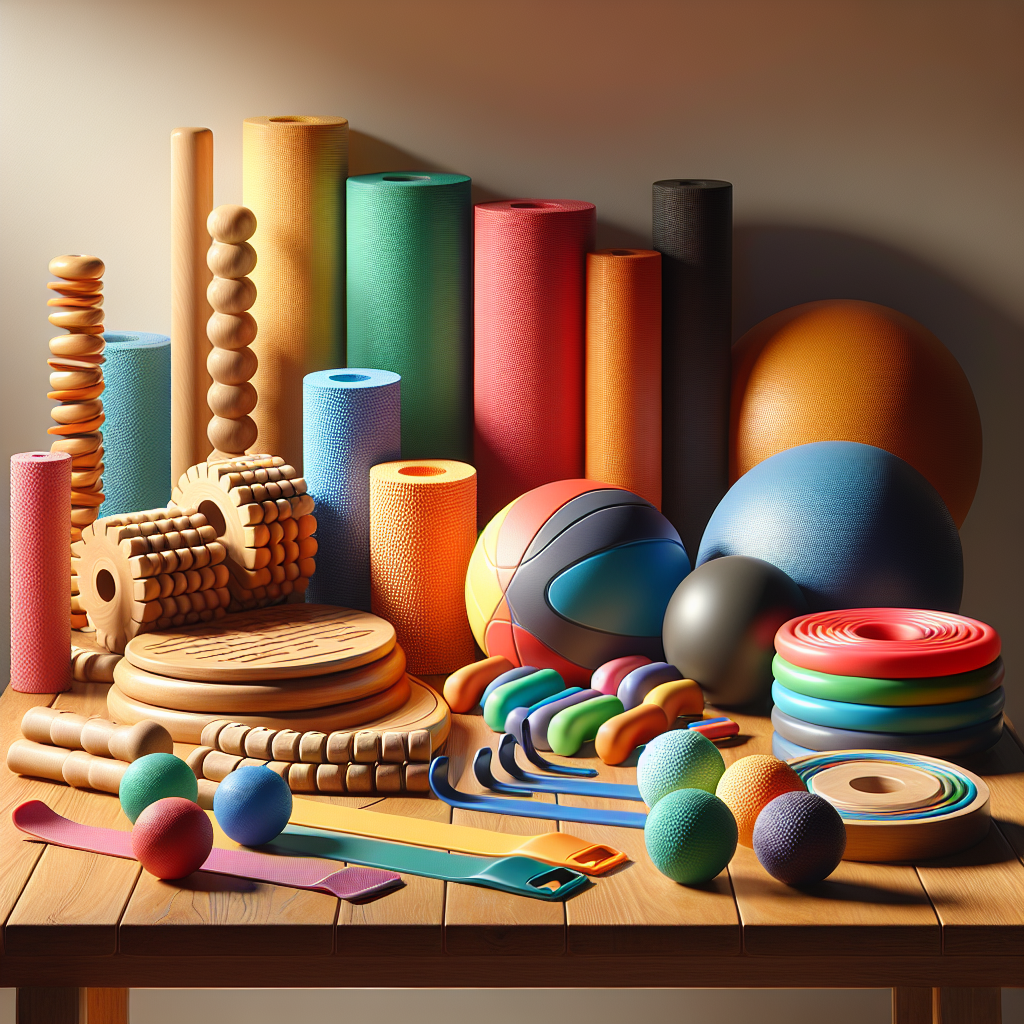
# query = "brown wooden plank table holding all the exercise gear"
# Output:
<box><xmin>0</xmin><ymin>684</ymin><xmax>1024</xmax><ymax>1024</ymax></box>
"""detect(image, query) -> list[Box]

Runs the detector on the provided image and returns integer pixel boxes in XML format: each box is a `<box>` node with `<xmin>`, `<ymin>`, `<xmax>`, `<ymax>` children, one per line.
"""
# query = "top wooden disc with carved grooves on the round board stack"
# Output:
<box><xmin>125</xmin><ymin>604</ymin><xmax>394</xmax><ymax>683</ymax></box>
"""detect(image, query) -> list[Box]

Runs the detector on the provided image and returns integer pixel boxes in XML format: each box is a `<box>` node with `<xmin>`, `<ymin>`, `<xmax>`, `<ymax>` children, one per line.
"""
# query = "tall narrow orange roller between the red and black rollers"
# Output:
<box><xmin>587</xmin><ymin>249</ymin><xmax>662</xmax><ymax>508</ymax></box>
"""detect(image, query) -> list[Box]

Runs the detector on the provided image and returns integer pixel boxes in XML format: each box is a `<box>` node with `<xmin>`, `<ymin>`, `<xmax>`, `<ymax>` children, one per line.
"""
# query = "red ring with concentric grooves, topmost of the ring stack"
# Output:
<box><xmin>775</xmin><ymin>608</ymin><xmax>1001</xmax><ymax>679</ymax></box>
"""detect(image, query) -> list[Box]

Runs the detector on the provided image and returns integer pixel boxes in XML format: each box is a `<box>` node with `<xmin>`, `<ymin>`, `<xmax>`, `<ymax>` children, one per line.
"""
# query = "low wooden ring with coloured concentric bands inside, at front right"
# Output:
<box><xmin>790</xmin><ymin>751</ymin><xmax>990</xmax><ymax>861</ymax></box>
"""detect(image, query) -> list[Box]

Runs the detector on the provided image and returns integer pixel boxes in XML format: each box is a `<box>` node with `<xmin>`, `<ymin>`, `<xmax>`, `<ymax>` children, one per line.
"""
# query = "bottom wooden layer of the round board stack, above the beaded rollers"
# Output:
<box><xmin>106</xmin><ymin>675</ymin><xmax>452</xmax><ymax>751</ymax></box>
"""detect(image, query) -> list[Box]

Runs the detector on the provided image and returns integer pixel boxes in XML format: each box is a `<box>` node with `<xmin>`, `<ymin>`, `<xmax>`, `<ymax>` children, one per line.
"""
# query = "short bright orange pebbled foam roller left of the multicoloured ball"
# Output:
<box><xmin>370</xmin><ymin>459</ymin><xmax>476</xmax><ymax>675</ymax></box>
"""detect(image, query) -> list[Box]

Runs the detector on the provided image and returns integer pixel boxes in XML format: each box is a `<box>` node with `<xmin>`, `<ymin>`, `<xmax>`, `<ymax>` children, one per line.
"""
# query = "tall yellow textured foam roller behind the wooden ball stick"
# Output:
<box><xmin>242</xmin><ymin>117</ymin><xmax>348</xmax><ymax>472</ymax></box>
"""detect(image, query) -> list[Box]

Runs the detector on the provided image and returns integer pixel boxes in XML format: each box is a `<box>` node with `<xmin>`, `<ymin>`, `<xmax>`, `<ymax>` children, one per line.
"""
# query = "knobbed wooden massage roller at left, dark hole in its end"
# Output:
<box><xmin>72</xmin><ymin>507</ymin><xmax>230</xmax><ymax>653</ymax></box>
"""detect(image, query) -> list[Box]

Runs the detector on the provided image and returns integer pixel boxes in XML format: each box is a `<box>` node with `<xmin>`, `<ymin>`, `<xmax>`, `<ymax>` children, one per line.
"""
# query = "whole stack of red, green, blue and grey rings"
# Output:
<box><xmin>772</xmin><ymin>608</ymin><xmax>1005</xmax><ymax>760</ymax></box>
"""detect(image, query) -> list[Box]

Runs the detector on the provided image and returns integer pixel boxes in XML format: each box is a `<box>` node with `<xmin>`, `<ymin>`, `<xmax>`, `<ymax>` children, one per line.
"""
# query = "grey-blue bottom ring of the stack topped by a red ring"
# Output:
<box><xmin>771</xmin><ymin>708</ymin><xmax>1002</xmax><ymax>758</ymax></box>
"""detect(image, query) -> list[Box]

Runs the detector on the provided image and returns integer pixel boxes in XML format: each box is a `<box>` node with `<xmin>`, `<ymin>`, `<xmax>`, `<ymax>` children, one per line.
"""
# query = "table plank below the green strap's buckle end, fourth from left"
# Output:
<box><xmin>444</xmin><ymin>714</ymin><xmax>565</xmax><ymax>956</ymax></box>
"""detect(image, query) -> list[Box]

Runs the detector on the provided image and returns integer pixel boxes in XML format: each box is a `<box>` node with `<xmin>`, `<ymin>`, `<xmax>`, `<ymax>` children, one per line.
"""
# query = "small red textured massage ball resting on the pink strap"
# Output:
<box><xmin>131</xmin><ymin>797</ymin><xmax>213</xmax><ymax>879</ymax></box>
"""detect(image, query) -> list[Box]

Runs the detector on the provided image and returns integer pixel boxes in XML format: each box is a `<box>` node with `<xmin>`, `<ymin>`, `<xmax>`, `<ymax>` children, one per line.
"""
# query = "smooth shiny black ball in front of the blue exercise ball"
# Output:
<box><xmin>662</xmin><ymin>555</ymin><xmax>807</xmax><ymax>708</ymax></box>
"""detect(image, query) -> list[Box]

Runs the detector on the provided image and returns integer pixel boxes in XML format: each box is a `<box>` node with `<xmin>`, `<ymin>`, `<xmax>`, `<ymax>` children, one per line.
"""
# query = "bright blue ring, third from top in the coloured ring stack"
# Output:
<box><xmin>771</xmin><ymin>681</ymin><xmax>1006</xmax><ymax>732</ymax></box>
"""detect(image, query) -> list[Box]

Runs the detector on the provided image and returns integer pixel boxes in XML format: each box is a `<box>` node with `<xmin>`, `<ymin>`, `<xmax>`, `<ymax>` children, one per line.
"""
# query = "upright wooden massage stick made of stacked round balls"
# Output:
<box><xmin>206</xmin><ymin>206</ymin><xmax>259</xmax><ymax>462</ymax></box>
